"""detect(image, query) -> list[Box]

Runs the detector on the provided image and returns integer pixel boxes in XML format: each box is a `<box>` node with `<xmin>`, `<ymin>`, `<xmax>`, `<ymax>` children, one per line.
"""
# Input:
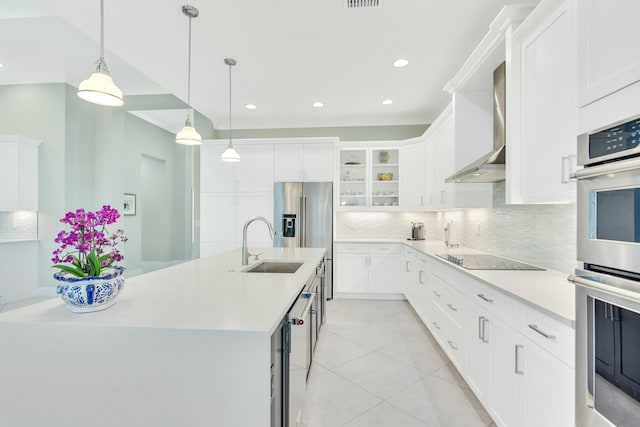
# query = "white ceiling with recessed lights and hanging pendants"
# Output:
<box><xmin>0</xmin><ymin>0</ymin><xmax>538</xmax><ymax>129</ymax></box>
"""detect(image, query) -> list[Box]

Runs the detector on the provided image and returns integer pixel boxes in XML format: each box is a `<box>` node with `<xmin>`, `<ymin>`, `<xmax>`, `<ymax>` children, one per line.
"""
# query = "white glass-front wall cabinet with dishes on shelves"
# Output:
<box><xmin>338</xmin><ymin>147</ymin><xmax>400</xmax><ymax>210</ymax></box>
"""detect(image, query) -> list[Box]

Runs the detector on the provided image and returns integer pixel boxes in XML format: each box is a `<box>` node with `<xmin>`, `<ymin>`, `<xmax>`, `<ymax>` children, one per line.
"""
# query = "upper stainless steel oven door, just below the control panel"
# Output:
<box><xmin>576</xmin><ymin>158</ymin><xmax>640</xmax><ymax>273</ymax></box>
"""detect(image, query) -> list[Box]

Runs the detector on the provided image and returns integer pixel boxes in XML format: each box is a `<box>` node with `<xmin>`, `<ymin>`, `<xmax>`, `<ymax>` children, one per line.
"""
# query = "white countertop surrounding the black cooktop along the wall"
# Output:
<box><xmin>336</xmin><ymin>239</ymin><xmax>576</xmax><ymax>328</ymax></box>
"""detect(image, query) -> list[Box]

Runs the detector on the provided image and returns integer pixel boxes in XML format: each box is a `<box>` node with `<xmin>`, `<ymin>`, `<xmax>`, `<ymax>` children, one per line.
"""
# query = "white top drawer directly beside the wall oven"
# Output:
<box><xmin>520</xmin><ymin>304</ymin><xmax>575</xmax><ymax>367</ymax></box>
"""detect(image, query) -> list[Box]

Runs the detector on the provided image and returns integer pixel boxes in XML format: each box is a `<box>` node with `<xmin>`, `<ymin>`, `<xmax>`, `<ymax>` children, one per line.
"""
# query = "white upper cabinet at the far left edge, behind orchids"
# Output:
<box><xmin>0</xmin><ymin>136</ymin><xmax>40</xmax><ymax>211</ymax></box>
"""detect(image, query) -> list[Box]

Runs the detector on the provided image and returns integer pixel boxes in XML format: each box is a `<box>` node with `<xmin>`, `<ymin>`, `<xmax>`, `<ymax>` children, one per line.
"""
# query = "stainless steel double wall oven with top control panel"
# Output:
<box><xmin>570</xmin><ymin>118</ymin><xmax>640</xmax><ymax>427</ymax></box>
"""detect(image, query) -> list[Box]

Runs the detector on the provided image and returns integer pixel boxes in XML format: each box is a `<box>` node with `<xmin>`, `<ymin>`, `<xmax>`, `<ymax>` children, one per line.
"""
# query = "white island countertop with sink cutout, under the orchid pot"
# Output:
<box><xmin>0</xmin><ymin>248</ymin><xmax>325</xmax><ymax>334</ymax></box>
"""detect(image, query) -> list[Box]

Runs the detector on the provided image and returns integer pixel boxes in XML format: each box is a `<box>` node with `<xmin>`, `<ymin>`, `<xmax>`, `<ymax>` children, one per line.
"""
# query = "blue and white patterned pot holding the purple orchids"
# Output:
<box><xmin>53</xmin><ymin>267</ymin><xmax>124</xmax><ymax>313</ymax></box>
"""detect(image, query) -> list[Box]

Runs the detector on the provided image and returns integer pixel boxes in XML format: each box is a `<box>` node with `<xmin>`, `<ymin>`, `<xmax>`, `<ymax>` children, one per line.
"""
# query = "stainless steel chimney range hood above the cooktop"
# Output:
<box><xmin>445</xmin><ymin>62</ymin><xmax>506</xmax><ymax>182</ymax></box>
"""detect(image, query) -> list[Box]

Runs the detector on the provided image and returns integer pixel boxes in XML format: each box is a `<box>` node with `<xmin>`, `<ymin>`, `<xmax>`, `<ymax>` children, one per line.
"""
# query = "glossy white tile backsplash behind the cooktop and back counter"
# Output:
<box><xmin>336</xmin><ymin>204</ymin><xmax>576</xmax><ymax>273</ymax></box>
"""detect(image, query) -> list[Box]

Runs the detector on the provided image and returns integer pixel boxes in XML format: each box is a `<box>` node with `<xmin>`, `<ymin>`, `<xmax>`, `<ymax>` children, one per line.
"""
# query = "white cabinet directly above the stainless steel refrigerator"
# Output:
<box><xmin>274</xmin><ymin>141</ymin><xmax>334</xmax><ymax>182</ymax></box>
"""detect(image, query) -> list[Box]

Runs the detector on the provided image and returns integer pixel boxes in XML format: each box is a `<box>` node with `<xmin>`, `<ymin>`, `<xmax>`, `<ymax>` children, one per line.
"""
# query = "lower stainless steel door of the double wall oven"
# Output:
<box><xmin>573</xmin><ymin>270</ymin><xmax>640</xmax><ymax>427</ymax></box>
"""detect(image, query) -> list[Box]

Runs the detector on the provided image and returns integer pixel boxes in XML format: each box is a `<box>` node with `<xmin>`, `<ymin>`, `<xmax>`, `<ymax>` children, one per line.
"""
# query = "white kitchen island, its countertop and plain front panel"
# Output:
<box><xmin>0</xmin><ymin>248</ymin><xmax>325</xmax><ymax>427</ymax></box>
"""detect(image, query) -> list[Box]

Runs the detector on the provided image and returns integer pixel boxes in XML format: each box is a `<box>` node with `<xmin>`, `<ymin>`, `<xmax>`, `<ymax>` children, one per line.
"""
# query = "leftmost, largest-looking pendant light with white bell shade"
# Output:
<box><xmin>78</xmin><ymin>0</ymin><xmax>124</xmax><ymax>107</ymax></box>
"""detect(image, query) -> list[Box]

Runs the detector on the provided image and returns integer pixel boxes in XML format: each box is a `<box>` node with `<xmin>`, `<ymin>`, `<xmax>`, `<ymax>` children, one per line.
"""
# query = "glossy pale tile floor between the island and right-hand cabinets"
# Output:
<box><xmin>302</xmin><ymin>299</ymin><xmax>495</xmax><ymax>427</ymax></box>
